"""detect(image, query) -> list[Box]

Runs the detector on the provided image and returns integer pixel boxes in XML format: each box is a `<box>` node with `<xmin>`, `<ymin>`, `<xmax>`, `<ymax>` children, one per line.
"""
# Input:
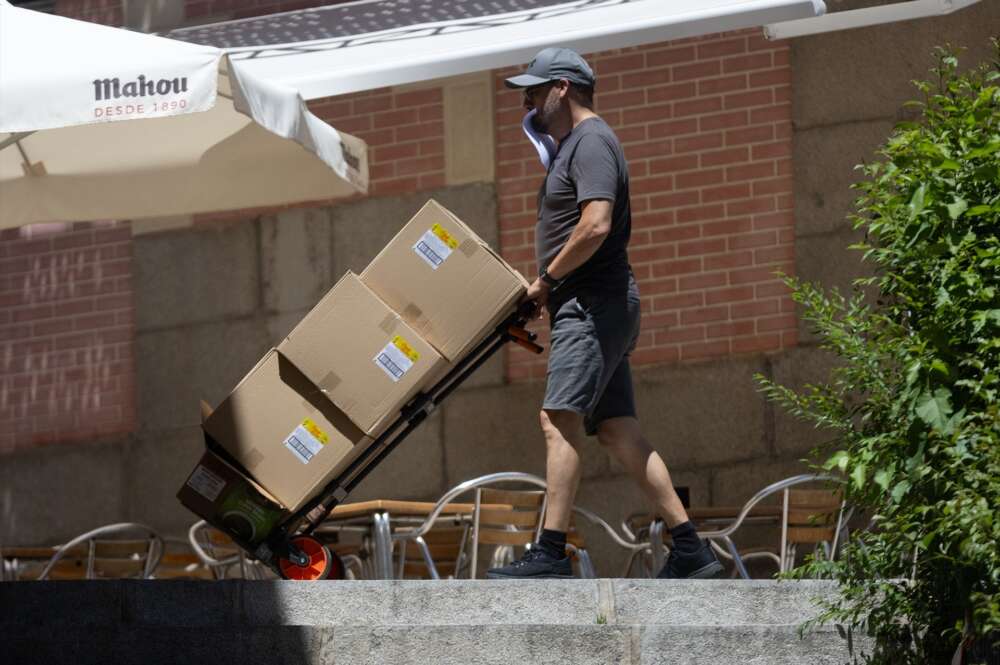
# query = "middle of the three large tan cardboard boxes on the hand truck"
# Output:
<box><xmin>276</xmin><ymin>272</ymin><xmax>444</xmax><ymax>436</ymax></box>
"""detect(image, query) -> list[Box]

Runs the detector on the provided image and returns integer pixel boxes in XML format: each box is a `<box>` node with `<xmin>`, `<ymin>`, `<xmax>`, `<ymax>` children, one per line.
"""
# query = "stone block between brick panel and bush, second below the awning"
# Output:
<box><xmin>792</xmin><ymin>120</ymin><xmax>893</xmax><ymax>240</ymax></box>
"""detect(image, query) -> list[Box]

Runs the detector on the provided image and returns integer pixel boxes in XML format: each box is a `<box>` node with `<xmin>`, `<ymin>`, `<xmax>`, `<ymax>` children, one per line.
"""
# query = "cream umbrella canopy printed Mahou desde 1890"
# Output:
<box><xmin>0</xmin><ymin>0</ymin><xmax>368</xmax><ymax>228</ymax></box>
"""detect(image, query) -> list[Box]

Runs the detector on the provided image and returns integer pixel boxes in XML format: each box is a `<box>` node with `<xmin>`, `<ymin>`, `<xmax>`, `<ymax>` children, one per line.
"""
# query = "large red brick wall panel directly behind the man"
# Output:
<box><xmin>496</xmin><ymin>30</ymin><xmax>796</xmax><ymax>380</ymax></box>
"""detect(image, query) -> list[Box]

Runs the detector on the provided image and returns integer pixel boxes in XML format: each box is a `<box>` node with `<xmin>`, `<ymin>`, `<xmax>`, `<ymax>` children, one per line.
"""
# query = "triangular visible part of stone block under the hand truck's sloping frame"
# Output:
<box><xmin>349</xmin><ymin>412</ymin><xmax>447</xmax><ymax>501</ymax></box>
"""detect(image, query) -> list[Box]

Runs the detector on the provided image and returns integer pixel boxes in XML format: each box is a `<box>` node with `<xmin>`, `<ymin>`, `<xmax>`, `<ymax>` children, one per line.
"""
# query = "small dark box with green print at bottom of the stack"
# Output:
<box><xmin>177</xmin><ymin>450</ymin><xmax>288</xmax><ymax>546</ymax></box>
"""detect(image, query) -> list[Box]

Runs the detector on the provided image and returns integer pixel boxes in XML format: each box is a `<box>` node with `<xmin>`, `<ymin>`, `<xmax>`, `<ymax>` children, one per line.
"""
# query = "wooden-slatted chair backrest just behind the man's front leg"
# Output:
<box><xmin>469</xmin><ymin>487</ymin><xmax>546</xmax><ymax>578</ymax></box>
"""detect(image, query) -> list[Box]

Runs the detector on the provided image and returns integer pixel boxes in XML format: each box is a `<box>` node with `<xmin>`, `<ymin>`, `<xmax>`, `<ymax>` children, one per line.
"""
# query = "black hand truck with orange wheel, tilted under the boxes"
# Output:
<box><xmin>205</xmin><ymin>301</ymin><xmax>543</xmax><ymax>580</ymax></box>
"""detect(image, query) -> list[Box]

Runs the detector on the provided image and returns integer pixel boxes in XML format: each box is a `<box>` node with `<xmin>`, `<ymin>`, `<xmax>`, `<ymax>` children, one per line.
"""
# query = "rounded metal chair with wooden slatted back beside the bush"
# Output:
<box><xmin>650</xmin><ymin>474</ymin><xmax>850</xmax><ymax>579</ymax></box>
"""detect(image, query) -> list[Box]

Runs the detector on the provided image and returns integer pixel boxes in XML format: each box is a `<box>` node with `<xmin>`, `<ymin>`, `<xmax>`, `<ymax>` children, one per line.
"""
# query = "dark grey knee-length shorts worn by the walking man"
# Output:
<box><xmin>542</xmin><ymin>280</ymin><xmax>639</xmax><ymax>436</ymax></box>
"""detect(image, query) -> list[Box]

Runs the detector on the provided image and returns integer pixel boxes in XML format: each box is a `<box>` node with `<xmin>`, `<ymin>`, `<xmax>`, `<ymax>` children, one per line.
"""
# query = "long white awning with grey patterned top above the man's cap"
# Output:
<box><xmin>169</xmin><ymin>0</ymin><xmax>826</xmax><ymax>99</ymax></box>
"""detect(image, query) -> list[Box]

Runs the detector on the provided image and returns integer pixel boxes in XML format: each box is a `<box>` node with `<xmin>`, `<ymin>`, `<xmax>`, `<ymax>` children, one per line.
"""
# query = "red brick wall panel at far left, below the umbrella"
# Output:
<box><xmin>0</xmin><ymin>223</ymin><xmax>135</xmax><ymax>453</ymax></box>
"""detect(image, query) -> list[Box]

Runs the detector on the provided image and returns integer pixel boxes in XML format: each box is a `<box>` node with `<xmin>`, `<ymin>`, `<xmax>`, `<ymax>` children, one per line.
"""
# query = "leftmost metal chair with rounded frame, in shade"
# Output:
<box><xmin>36</xmin><ymin>522</ymin><xmax>164</xmax><ymax>580</ymax></box>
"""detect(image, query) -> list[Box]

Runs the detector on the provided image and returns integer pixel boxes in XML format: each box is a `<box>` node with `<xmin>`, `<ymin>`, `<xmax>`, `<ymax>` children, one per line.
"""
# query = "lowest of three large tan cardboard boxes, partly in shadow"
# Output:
<box><xmin>204</xmin><ymin>350</ymin><xmax>371</xmax><ymax>512</ymax></box>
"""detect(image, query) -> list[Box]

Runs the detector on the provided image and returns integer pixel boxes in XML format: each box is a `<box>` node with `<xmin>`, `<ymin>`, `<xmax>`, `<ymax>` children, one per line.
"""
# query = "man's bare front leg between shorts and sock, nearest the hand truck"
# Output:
<box><xmin>539</xmin><ymin>409</ymin><xmax>583</xmax><ymax>533</ymax></box>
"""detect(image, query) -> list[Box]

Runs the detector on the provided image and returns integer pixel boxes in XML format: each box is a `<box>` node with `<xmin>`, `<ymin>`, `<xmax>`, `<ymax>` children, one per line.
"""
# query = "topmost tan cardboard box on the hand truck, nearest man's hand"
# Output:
<box><xmin>361</xmin><ymin>199</ymin><xmax>528</xmax><ymax>361</ymax></box>
